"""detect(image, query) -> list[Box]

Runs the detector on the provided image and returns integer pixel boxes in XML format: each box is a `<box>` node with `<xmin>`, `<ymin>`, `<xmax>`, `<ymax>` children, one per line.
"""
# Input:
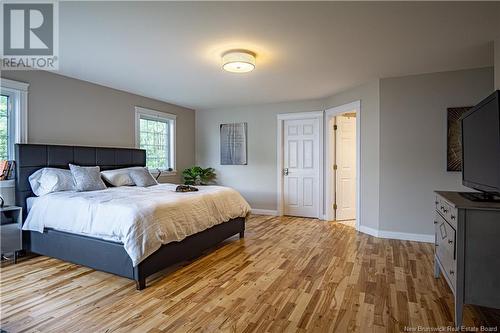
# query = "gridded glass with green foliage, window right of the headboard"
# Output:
<box><xmin>139</xmin><ymin>118</ymin><xmax>170</xmax><ymax>170</ymax></box>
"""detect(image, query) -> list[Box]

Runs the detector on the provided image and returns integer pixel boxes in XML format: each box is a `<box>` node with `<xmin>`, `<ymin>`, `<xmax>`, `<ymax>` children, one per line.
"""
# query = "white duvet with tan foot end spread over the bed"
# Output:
<box><xmin>23</xmin><ymin>184</ymin><xmax>250</xmax><ymax>266</ymax></box>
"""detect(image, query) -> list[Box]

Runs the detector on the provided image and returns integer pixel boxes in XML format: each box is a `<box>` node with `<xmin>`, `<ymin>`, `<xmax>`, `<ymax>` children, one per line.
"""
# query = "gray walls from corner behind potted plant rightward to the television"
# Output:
<box><xmin>196</xmin><ymin>68</ymin><xmax>494</xmax><ymax>239</ymax></box>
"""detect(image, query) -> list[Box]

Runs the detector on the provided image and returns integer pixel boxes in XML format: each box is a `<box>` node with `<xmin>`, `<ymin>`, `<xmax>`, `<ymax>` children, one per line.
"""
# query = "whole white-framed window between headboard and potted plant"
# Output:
<box><xmin>135</xmin><ymin>107</ymin><xmax>176</xmax><ymax>172</ymax></box>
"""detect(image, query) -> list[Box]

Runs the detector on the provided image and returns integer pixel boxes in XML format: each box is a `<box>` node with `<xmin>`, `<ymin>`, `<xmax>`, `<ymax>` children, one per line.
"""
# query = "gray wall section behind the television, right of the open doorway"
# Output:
<box><xmin>379</xmin><ymin>68</ymin><xmax>493</xmax><ymax>235</ymax></box>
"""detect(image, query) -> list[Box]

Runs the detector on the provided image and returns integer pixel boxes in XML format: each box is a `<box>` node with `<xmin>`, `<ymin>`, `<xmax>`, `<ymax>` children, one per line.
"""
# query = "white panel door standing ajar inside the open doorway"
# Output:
<box><xmin>335</xmin><ymin>116</ymin><xmax>356</xmax><ymax>220</ymax></box>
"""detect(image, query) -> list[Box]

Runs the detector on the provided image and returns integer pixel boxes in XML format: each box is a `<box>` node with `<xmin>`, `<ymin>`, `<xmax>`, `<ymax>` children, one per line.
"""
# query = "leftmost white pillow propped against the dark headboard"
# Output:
<box><xmin>28</xmin><ymin>168</ymin><xmax>75</xmax><ymax>196</ymax></box>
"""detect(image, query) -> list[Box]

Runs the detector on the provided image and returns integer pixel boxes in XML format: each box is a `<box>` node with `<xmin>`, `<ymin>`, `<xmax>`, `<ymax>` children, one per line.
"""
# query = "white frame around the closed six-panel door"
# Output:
<box><xmin>276</xmin><ymin>111</ymin><xmax>324</xmax><ymax>218</ymax></box>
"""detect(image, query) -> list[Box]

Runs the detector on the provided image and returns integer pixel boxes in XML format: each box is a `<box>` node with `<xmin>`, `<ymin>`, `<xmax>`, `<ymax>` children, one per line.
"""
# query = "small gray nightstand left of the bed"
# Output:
<box><xmin>0</xmin><ymin>206</ymin><xmax>23</xmax><ymax>263</ymax></box>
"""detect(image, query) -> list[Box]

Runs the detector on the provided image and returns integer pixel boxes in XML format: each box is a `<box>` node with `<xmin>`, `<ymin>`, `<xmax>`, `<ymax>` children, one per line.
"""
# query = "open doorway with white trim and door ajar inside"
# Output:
<box><xmin>325</xmin><ymin>101</ymin><xmax>361</xmax><ymax>229</ymax></box>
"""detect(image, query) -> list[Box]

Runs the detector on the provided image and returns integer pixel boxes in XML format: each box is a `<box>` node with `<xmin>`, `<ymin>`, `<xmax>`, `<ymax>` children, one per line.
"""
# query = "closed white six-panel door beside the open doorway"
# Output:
<box><xmin>283</xmin><ymin>118</ymin><xmax>320</xmax><ymax>217</ymax></box>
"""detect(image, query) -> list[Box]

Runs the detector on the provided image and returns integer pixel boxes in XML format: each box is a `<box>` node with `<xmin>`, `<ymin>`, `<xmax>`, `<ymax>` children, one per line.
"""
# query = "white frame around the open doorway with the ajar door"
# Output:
<box><xmin>324</xmin><ymin>100</ymin><xmax>361</xmax><ymax>230</ymax></box>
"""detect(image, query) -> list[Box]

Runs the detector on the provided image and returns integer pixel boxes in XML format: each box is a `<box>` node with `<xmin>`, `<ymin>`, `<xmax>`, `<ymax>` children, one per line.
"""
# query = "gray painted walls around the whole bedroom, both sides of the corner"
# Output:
<box><xmin>6</xmin><ymin>68</ymin><xmax>495</xmax><ymax>234</ymax></box>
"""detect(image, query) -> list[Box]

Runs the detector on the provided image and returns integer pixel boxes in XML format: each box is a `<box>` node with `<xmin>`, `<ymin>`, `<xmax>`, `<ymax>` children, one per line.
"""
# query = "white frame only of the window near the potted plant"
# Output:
<box><xmin>135</xmin><ymin>106</ymin><xmax>177</xmax><ymax>175</ymax></box>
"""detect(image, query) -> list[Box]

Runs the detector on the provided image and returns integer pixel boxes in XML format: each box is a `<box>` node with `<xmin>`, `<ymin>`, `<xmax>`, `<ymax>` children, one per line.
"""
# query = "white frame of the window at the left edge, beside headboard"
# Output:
<box><xmin>0</xmin><ymin>78</ymin><xmax>29</xmax><ymax>160</ymax></box>
